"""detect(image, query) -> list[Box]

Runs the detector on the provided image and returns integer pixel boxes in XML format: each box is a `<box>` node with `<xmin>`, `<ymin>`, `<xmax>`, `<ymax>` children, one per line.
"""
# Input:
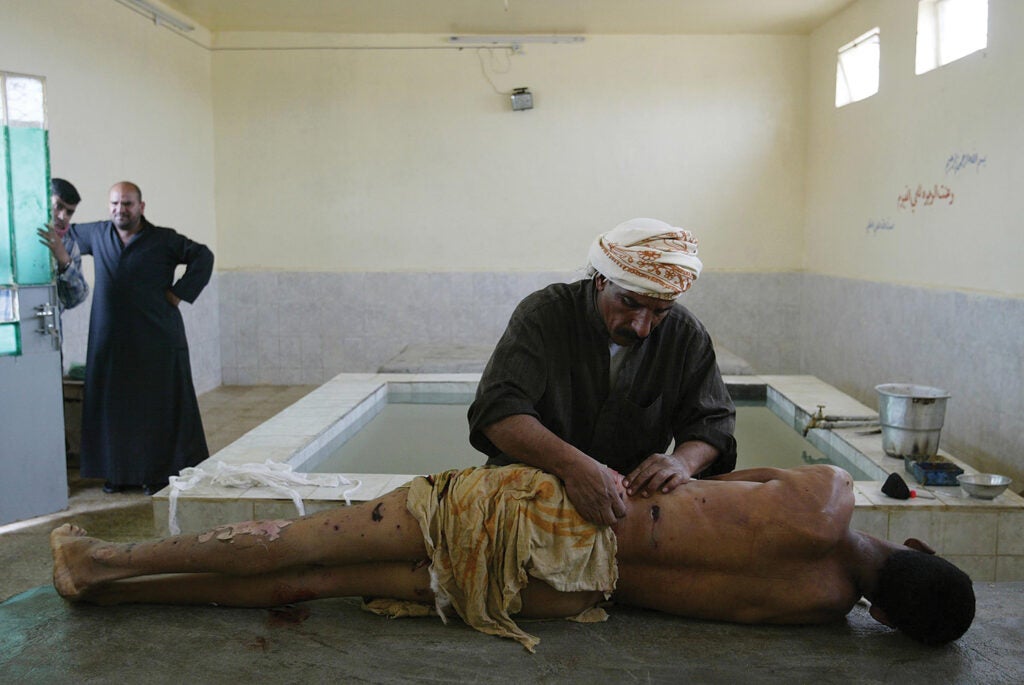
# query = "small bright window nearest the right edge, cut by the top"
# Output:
<box><xmin>915</xmin><ymin>0</ymin><xmax>988</xmax><ymax>74</ymax></box>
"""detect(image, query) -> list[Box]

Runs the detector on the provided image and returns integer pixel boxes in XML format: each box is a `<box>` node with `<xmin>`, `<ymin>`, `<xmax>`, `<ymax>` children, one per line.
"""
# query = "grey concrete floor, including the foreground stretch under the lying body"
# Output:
<box><xmin>0</xmin><ymin>386</ymin><xmax>1024</xmax><ymax>684</ymax></box>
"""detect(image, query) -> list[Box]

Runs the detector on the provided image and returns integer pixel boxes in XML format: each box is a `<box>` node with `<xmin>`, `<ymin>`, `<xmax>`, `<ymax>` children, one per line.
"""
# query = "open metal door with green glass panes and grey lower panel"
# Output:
<box><xmin>0</xmin><ymin>72</ymin><xmax>68</xmax><ymax>524</ymax></box>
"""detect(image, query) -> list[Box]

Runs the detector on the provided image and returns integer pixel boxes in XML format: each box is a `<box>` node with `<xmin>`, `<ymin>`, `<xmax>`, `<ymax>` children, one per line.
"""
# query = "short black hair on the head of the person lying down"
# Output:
<box><xmin>873</xmin><ymin>550</ymin><xmax>975</xmax><ymax>645</ymax></box>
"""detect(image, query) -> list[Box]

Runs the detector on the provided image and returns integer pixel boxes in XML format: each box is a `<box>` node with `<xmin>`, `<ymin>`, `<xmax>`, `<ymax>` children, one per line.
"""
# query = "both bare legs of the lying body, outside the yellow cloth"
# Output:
<box><xmin>50</xmin><ymin>483</ymin><xmax>601</xmax><ymax>617</ymax></box>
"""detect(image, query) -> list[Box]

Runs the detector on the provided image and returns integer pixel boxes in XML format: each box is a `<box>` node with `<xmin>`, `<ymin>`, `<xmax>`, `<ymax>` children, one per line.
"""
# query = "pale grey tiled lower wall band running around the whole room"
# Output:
<box><xmin>209</xmin><ymin>271</ymin><xmax>1024</xmax><ymax>490</ymax></box>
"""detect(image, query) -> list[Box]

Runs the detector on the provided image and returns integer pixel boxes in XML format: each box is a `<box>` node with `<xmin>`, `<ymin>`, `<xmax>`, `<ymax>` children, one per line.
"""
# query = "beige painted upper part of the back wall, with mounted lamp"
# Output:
<box><xmin>213</xmin><ymin>34</ymin><xmax>807</xmax><ymax>271</ymax></box>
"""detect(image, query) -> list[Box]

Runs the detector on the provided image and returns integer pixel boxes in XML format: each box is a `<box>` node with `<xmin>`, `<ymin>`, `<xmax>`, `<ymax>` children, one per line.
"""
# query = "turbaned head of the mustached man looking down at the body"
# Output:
<box><xmin>588</xmin><ymin>219</ymin><xmax>701</xmax><ymax>345</ymax></box>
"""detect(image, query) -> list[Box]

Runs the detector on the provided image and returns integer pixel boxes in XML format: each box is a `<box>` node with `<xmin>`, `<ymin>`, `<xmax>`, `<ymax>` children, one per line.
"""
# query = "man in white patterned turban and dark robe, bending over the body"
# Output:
<box><xmin>469</xmin><ymin>219</ymin><xmax>736</xmax><ymax>524</ymax></box>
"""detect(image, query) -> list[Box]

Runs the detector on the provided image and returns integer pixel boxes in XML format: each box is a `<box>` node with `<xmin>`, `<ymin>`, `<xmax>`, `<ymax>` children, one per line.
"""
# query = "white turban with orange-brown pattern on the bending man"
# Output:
<box><xmin>588</xmin><ymin>219</ymin><xmax>702</xmax><ymax>300</ymax></box>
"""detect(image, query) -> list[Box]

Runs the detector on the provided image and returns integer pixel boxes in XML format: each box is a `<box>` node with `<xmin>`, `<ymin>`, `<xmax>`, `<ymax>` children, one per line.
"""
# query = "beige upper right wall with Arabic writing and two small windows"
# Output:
<box><xmin>806</xmin><ymin>0</ymin><xmax>1024</xmax><ymax>296</ymax></box>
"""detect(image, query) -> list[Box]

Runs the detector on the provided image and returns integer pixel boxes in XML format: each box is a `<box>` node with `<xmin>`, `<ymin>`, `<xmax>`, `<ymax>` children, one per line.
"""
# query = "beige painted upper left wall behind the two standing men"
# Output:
<box><xmin>0</xmin><ymin>0</ymin><xmax>217</xmax><ymax>252</ymax></box>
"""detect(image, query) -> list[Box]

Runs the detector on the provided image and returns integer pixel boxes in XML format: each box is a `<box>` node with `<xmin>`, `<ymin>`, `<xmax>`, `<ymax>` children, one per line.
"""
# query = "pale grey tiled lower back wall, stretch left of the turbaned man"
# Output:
<box><xmin>220</xmin><ymin>271</ymin><xmax>573</xmax><ymax>384</ymax></box>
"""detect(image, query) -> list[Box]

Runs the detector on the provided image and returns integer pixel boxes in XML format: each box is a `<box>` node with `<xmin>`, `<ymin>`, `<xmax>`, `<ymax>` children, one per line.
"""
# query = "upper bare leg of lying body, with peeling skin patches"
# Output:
<box><xmin>50</xmin><ymin>489</ymin><xmax>426</xmax><ymax>599</ymax></box>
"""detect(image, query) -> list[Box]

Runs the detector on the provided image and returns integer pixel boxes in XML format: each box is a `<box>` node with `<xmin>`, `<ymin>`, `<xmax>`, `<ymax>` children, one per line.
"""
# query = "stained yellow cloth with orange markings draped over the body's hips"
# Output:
<box><xmin>408</xmin><ymin>465</ymin><xmax>618</xmax><ymax>651</ymax></box>
